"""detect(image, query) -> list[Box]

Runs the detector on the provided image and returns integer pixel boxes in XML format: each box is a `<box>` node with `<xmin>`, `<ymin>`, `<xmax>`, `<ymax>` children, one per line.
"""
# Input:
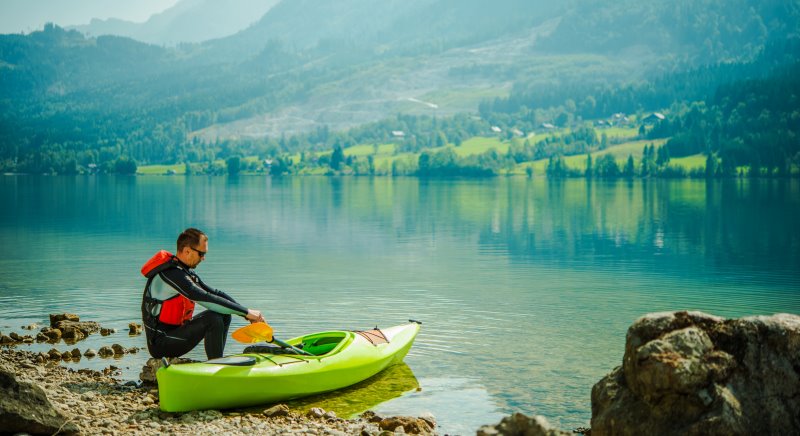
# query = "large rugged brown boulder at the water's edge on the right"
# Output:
<box><xmin>592</xmin><ymin>312</ymin><xmax>800</xmax><ymax>436</ymax></box>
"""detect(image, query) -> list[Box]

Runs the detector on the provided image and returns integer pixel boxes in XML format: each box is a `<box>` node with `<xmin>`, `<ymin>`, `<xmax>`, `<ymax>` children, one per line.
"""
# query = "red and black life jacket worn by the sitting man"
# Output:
<box><xmin>142</xmin><ymin>250</ymin><xmax>195</xmax><ymax>326</ymax></box>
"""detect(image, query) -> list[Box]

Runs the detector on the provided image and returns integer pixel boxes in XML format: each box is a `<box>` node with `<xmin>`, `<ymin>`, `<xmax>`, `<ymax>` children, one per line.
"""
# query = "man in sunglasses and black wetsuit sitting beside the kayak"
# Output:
<box><xmin>142</xmin><ymin>228</ymin><xmax>264</xmax><ymax>359</ymax></box>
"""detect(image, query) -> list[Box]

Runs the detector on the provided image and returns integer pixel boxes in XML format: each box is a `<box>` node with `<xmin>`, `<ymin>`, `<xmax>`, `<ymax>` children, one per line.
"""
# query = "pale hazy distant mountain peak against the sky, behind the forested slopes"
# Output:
<box><xmin>69</xmin><ymin>0</ymin><xmax>280</xmax><ymax>46</ymax></box>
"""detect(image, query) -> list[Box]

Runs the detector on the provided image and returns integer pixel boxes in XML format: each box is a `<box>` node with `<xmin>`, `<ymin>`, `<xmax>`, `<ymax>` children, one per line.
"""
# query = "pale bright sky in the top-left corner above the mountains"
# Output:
<box><xmin>0</xmin><ymin>0</ymin><xmax>178</xmax><ymax>33</ymax></box>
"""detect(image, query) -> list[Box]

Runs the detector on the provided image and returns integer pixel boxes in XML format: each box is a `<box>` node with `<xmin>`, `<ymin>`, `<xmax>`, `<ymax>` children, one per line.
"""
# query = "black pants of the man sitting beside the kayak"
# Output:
<box><xmin>145</xmin><ymin>310</ymin><xmax>231</xmax><ymax>359</ymax></box>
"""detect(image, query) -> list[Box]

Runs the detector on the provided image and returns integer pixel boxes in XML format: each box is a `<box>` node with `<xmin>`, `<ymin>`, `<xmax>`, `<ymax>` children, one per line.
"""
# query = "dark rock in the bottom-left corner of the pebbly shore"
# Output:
<box><xmin>0</xmin><ymin>369</ymin><xmax>78</xmax><ymax>434</ymax></box>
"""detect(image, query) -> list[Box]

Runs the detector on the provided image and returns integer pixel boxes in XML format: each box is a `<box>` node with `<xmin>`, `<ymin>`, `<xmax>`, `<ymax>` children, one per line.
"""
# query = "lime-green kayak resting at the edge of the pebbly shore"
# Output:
<box><xmin>156</xmin><ymin>322</ymin><xmax>419</xmax><ymax>412</ymax></box>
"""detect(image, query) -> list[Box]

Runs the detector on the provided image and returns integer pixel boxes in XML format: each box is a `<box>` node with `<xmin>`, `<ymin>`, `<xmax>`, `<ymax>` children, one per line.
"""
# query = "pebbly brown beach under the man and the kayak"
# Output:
<box><xmin>0</xmin><ymin>347</ymin><xmax>435</xmax><ymax>435</ymax></box>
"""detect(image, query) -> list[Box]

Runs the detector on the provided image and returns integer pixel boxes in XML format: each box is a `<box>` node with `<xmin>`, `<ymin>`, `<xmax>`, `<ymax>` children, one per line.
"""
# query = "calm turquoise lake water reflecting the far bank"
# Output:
<box><xmin>0</xmin><ymin>176</ymin><xmax>800</xmax><ymax>434</ymax></box>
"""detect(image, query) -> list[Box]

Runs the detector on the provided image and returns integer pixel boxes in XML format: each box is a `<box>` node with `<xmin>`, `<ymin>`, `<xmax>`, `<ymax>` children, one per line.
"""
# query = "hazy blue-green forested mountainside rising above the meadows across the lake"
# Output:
<box><xmin>0</xmin><ymin>0</ymin><xmax>800</xmax><ymax>173</ymax></box>
